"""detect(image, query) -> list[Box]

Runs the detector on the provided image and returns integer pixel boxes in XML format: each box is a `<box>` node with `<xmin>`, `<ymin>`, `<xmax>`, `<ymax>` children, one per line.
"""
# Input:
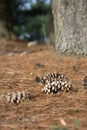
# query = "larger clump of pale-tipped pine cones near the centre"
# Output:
<box><xmin>35</xmin><ymin>73</ymin><xmax>72</xmax><ymax>94</ymax></box>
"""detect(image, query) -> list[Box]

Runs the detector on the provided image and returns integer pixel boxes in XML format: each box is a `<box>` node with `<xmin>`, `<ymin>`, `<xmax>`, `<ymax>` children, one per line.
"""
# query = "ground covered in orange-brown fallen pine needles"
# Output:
<box><xmin>0</xmin><ymin>39</ymin><xmax>87</xmax><ymax>130</ymax></box>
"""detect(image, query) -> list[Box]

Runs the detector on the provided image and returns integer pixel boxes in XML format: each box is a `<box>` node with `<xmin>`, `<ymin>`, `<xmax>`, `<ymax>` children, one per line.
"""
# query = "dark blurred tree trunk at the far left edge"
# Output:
<box><xmin>0</xmin><ymin>0</ymin><xmax>12</xmax><ymax>39</ymax></box>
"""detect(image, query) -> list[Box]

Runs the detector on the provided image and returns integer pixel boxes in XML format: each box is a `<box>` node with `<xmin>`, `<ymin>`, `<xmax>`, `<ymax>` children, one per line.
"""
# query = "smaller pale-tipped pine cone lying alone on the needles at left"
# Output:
<box><xmin>5</xmin><ymin>91</ymin><xmax>29</xmax><ymax>104</ymax></box>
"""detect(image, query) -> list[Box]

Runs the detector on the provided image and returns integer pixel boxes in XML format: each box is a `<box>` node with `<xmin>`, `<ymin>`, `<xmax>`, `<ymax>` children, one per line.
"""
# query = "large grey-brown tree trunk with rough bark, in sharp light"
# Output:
<box><xmin>51</xmin><ymin>0</ymin><xmax>87</xmax><ymax>55</ymax></box>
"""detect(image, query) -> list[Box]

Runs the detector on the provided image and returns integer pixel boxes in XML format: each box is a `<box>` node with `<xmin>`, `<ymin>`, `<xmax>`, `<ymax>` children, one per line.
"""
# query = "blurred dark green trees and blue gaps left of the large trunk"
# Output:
<box><xmin>0</xmin><ymin>0</ymin><xmax>51</xmax><ymax>42</ymax></box>
